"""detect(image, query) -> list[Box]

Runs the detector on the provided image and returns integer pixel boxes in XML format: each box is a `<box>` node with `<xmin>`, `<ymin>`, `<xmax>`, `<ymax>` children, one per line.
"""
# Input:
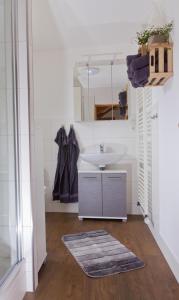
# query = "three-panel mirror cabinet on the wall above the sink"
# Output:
<box><xmin>73</xmin><ymin>54</ymin><xmax>128</xmax><ymax>122</ymax></box>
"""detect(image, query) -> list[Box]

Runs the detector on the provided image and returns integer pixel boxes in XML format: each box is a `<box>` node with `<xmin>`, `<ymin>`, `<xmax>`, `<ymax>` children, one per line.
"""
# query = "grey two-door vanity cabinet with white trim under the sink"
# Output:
<box><xmin>78</xmin><ymin>171</ymin><xmax>127</xmax><ymax>220</ymax></box>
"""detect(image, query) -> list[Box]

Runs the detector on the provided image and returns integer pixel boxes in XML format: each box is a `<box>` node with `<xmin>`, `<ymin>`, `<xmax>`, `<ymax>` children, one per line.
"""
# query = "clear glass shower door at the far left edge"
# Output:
<box><xmin>0</xmin><ymin>0</ymin><xmax>20</xmax><ymax>283</ymax></box>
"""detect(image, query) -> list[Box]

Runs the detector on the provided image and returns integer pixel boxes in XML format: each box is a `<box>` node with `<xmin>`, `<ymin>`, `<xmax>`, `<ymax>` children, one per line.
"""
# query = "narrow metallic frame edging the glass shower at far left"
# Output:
<box><xmin>0</xmin><ymin>0</ymin><xmax>22</xmax><ymax>286</ymax></box>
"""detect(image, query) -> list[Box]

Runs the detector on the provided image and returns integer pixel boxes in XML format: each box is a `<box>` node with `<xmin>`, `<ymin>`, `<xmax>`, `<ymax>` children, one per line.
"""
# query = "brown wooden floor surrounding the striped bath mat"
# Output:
<box><xmin>24</xmin><ymin>213</ymin><xmax>179</xmax><ymax>300</ymax></box>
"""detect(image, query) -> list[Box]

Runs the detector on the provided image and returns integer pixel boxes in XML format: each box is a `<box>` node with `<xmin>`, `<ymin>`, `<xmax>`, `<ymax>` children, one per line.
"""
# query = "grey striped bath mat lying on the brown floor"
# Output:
<box><xmin>62</xmin><ymin>230</ymin><xmax>144</xmax><ymax>277</ymax></box>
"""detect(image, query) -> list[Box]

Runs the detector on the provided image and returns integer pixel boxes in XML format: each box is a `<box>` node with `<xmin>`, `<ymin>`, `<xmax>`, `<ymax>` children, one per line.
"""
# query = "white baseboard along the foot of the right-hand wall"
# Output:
<box><xmin>145</xmin><ymin>220</ymin><xmax>179</xmax><ymax>283</ymax></box>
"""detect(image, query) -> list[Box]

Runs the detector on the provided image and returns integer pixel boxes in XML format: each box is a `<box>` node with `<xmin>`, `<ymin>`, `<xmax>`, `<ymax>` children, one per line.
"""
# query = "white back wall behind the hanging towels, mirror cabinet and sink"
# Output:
<box><xmin>34</xmin><ymin>50</ymin><xmax>138</xmax><ymax>213</ymax></box>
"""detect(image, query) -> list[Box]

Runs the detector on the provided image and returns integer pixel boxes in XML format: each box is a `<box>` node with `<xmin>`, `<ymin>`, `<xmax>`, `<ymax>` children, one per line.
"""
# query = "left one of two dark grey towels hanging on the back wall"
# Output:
<box><xmin>53</xmin><ymin>127</ymin><xmax>69</xmax><ymax>203</ymax></box>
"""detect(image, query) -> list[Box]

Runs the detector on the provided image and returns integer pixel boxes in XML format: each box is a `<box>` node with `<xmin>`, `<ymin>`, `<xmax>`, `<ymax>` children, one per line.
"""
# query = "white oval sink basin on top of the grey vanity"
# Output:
<box><xmin>80</xmin><ymin>152</ymin><xmax>122</xmax><ymax>168</ymax></box>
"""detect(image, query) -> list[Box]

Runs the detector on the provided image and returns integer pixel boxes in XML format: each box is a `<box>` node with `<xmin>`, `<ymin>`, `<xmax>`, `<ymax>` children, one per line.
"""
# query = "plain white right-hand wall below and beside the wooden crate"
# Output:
<box><xmin>149</xmin><ymin>0</ymin><xmax>179</xmax><ymax>281</ymax></box>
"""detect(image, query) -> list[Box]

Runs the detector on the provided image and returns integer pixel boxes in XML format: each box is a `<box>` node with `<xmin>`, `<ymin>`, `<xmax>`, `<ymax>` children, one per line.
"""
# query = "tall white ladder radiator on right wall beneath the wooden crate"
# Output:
<box><xmin>136</xmin><ymin>88</ymin><xmax>152</xmax><ymax>220</ymax></box>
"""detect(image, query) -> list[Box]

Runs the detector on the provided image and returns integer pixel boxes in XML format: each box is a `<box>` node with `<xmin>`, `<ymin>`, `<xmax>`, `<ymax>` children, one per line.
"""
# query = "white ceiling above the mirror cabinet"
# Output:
<box><xmin>32</xmin><ymin>0</ymin><xmax>164</xmax><ymax>49</ymax></box>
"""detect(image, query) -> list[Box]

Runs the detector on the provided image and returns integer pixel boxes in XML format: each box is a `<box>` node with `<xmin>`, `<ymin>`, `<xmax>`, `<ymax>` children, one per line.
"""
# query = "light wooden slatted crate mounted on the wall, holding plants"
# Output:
<box><xmin>141</xmin><ymin>43</ymin><xmax>173</xmax><ymax>86</ymax></box>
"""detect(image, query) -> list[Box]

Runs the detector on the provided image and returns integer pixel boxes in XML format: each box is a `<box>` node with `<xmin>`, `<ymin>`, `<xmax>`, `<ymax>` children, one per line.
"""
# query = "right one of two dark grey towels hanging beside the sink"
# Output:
<box><xmin>68</xmin><ymin>126</ymin><xmax>80</xmax><ymax>203</ymax></box>
